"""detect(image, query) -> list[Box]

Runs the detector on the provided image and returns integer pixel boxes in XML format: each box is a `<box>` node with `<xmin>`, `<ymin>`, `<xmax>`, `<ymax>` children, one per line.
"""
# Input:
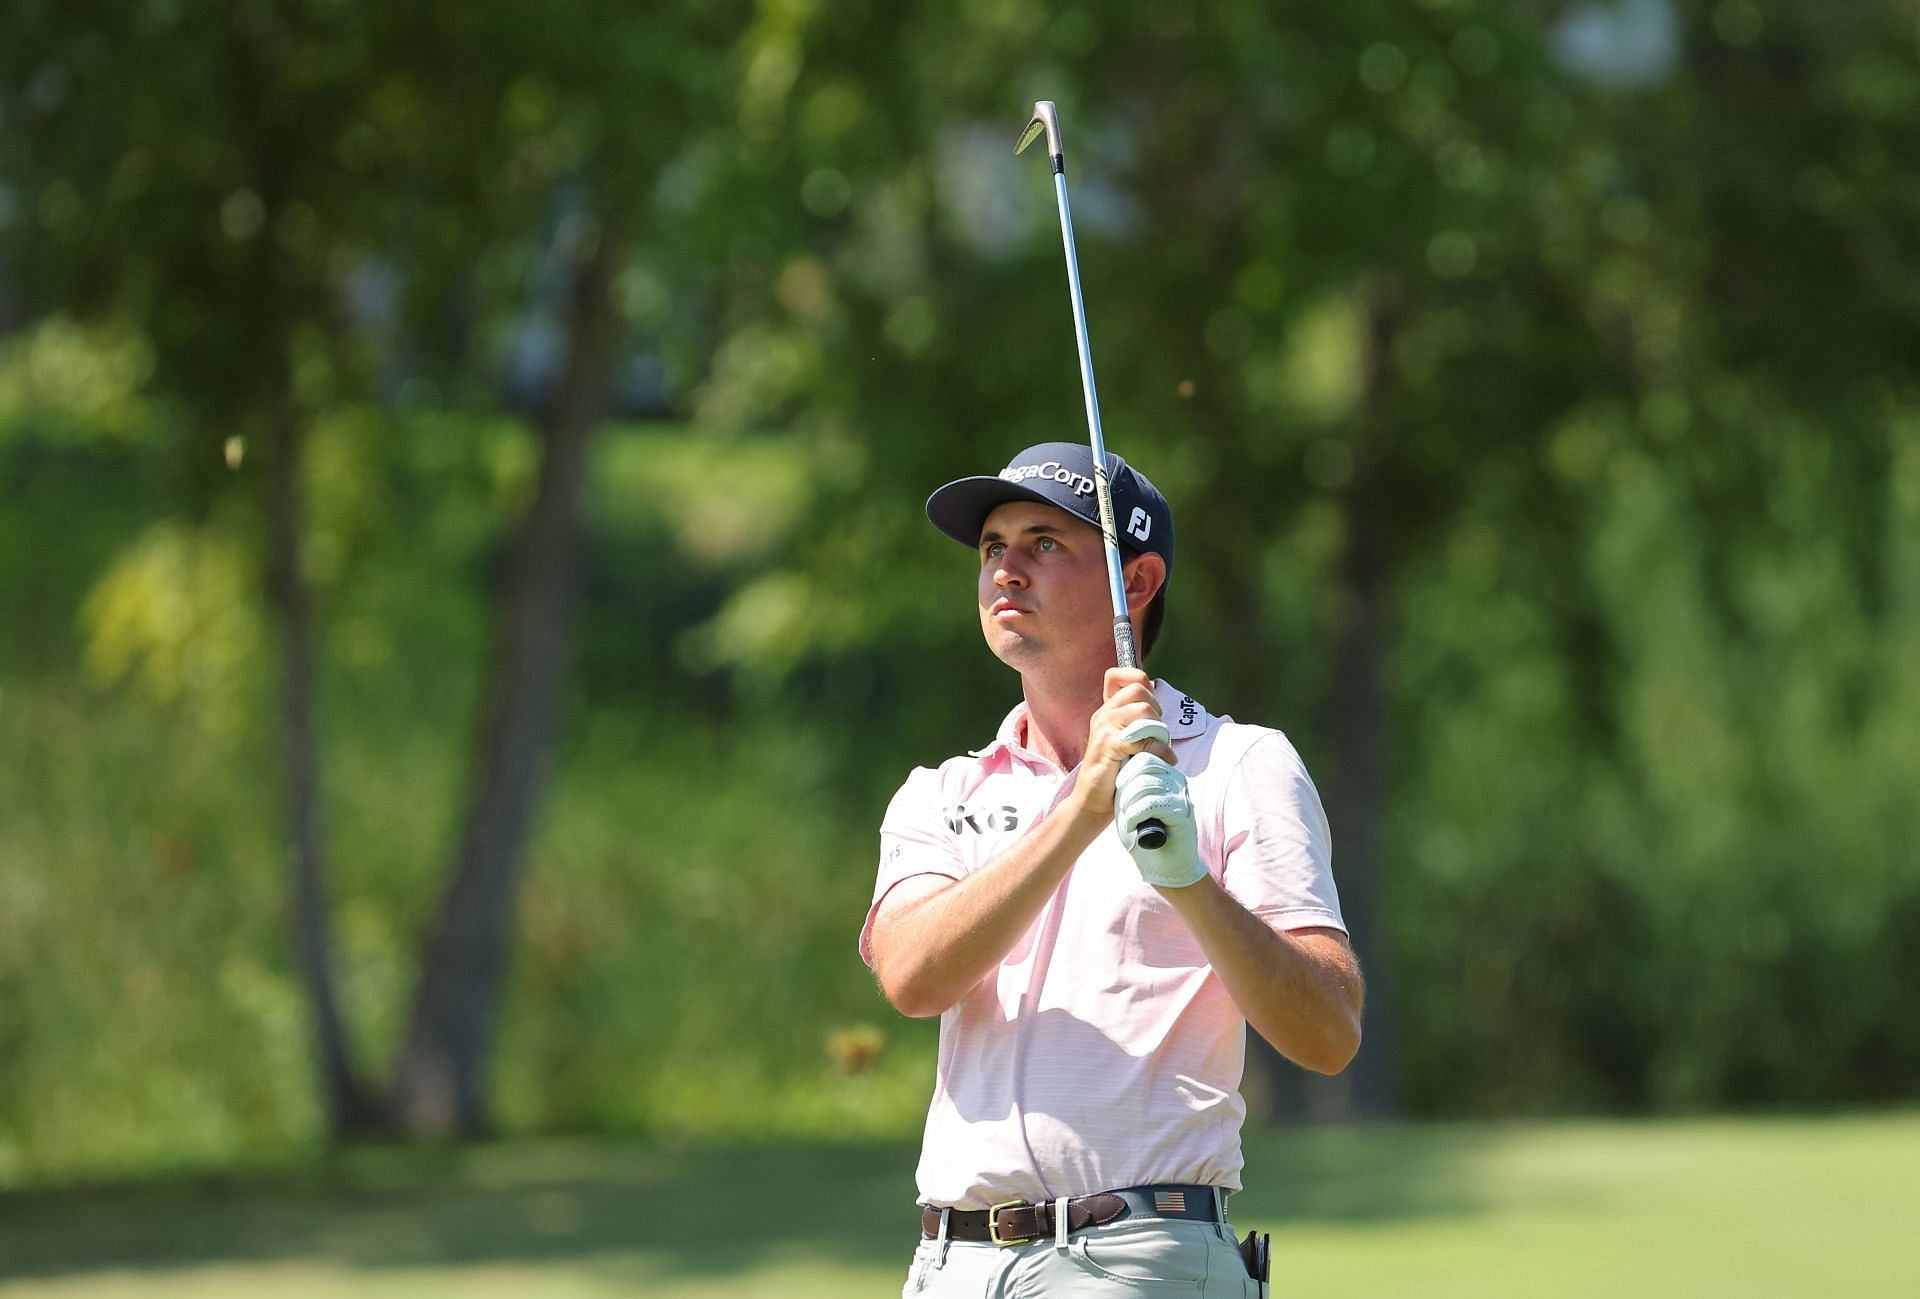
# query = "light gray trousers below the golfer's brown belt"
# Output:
<box><xmin>900</xmin><ymin>1218</ymin><xmax>1265</xmax><ymax>1299</ymax></box>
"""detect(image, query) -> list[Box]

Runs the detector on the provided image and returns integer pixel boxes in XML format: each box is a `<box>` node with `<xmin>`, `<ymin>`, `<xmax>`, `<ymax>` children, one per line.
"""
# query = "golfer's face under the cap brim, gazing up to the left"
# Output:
<box><xmin>979</xmin><ymin>501</ymin><xmax>1114</xmax><ymax>670</ymax></box>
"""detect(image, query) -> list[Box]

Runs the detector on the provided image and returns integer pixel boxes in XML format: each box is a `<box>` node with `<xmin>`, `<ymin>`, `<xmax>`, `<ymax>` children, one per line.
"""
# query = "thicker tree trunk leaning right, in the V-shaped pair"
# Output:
<box><xmin>388</xmin><ymin>217</ymin><xmax>614</xmax><ymax>1136</ymax></box>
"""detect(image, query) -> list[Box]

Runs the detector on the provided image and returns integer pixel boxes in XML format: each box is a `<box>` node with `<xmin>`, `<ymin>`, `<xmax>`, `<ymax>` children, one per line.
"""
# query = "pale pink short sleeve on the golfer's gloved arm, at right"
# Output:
<box><xmin>1221</xmin><ymin>731</ymin><xmax>1346</xmax><ymax>933</ymax></box>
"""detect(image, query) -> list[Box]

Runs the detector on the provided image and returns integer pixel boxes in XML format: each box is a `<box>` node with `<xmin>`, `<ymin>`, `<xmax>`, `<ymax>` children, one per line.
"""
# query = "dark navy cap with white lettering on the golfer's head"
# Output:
<box><xmin>927</xmin><ymin>441</ymin><xmax>1173</xmax><ymax>576</ymax></box>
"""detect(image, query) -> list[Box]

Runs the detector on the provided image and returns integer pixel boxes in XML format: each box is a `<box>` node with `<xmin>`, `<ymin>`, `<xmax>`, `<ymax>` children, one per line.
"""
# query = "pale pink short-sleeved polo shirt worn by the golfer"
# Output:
<box><xmin>860</xmin><ymin>681</ymin><xmax>1346</xmax><ymax>1209</ymax></box>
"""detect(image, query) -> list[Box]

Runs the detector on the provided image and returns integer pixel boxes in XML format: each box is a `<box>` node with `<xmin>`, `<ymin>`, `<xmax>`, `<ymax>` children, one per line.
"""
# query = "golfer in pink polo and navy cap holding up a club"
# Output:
<box><xmin>860</xmin><ymin>443</ymin><xmax>1361</xmax><ymax>1299</ymax></box>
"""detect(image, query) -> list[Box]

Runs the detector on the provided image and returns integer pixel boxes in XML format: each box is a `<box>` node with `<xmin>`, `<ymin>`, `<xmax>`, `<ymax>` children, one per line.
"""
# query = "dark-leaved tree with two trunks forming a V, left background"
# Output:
<box><xmin>6</xmin><ymin>0</ymin><xmax>744</xmax><ymax>1134</ymax></box>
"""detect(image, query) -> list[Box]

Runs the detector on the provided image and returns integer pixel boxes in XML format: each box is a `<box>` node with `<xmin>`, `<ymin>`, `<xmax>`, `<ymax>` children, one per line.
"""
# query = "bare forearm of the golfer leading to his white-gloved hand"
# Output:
<box><xmin>1158</xmin><ymin>879</ymin><xmax>1365</xmax><ymax>1073</ymax></box>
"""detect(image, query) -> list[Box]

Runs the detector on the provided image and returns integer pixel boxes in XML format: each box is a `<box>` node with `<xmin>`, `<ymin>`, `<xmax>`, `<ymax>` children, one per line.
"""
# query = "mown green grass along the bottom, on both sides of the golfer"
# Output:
<box><xmin>0</xmin><ymin>1113</ymin><xmax>1920</xmax><ymax>1299</ymax></box>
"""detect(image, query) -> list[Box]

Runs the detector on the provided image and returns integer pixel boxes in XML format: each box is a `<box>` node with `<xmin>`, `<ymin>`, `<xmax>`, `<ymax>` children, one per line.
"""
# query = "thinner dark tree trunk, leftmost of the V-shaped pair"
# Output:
<box><xmin>265</xmin><ymin>393</ymin><xmax>372</xmax><ymax>1140</ymax></box>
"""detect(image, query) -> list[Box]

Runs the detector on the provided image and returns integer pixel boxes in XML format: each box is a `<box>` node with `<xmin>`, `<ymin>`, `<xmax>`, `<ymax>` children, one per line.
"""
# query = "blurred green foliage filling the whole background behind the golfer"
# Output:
<box><xmin>0</xmin><ymin>0</ymin><xmax>1920</xmax><ymax>1176</ymax></box>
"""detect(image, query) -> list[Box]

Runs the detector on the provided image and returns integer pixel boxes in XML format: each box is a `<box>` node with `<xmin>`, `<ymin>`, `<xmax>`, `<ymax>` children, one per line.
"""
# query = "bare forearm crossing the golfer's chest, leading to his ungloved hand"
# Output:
<box><xmin>874</xmin><ymin>794</ymin><xmax>1110</xmax><ymax>1017</ymax></box>
